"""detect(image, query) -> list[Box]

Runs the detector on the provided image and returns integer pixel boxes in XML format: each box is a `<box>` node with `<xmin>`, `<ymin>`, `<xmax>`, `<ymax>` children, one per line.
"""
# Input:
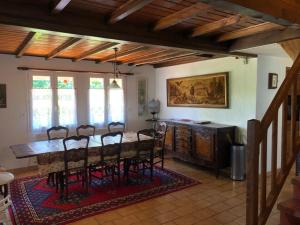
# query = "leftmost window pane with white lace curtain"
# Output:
<box><xmin>31</xmin><ymin>76</ymin><xmax>52</xmax><ymax>132</ymax></box>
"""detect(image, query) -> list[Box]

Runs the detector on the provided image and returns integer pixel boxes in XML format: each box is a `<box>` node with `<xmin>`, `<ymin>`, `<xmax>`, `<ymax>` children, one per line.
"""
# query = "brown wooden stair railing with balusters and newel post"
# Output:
<box><xmin>246</xmin><ymin>54</ymin><xmax>300</xmax><ymax>225</ymax></box>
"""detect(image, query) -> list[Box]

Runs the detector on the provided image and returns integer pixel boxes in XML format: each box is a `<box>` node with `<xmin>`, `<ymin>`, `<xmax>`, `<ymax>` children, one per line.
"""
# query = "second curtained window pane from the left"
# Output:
<box><xmin>57</xmin><ymin>77</ymin><xmax>77</xmax><ymax>126</ymax></box>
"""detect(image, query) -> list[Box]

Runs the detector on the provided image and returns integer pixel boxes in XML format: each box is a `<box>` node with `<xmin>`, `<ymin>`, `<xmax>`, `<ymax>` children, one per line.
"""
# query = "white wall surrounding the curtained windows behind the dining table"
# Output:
<box><xmin>0</xmin><ymin>55</ymin><xmax>155</xmax><ymax>168</ymax></box>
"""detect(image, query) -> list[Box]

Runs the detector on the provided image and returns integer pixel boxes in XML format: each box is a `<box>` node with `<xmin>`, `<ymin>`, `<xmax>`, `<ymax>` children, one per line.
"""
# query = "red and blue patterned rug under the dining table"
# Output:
<box><xmin>10</xmin><ymin>167</ymin><xmax>199</xmax><ymax>225</ymax></box>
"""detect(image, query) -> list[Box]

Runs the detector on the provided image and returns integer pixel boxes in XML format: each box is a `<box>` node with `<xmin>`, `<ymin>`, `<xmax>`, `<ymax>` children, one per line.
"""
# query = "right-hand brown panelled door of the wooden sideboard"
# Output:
<box><xmin>193</xmin><ymin>129</ymin><xmax>215</xmax><ymax>162</ymax></box>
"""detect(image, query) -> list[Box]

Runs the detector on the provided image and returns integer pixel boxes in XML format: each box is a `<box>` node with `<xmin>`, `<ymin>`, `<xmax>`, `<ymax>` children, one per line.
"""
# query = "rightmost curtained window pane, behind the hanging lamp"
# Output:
<box><xmin>108</xmin><ymin>79</ymin><xmax>124</xmax><ymax>122</ymax></box>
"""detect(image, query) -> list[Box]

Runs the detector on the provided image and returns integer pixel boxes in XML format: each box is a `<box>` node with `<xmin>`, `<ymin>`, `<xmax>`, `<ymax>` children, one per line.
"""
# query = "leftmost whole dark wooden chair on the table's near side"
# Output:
<box><xmin>59</xmin><ymin>135</ymin><xmax>90</xmax><ymax>199</ymax></box>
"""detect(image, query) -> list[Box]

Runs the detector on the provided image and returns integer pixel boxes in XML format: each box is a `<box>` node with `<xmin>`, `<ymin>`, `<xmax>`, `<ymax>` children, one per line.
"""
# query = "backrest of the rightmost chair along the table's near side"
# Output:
<box><xmin>137</xmin><ymin>129</ymin><xmax>156</xmax><ymax>156</ymax></box>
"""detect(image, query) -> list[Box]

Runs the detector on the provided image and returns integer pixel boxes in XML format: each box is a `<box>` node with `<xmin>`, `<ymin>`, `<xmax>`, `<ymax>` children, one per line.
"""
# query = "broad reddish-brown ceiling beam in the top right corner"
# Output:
<box><xmin>220</xmin><ymin>0</ymin><xmax>300</xmax><ymax>24</ymax></box>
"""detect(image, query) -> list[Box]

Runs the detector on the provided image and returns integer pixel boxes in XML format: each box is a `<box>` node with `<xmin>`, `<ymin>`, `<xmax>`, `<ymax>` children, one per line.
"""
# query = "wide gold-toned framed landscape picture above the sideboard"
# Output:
<box><xmin>167</xmin><ymin>72</ymin><xmax>229</xmax><ymax>108</ymax></box>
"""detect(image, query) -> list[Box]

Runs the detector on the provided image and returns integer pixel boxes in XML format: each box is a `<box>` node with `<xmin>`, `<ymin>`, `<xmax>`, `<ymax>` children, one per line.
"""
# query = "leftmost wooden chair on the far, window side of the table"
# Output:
<box><xmin>47</xmin><ymin>126</ymin><xmax>69</xmax><ymax>185</ymax></box>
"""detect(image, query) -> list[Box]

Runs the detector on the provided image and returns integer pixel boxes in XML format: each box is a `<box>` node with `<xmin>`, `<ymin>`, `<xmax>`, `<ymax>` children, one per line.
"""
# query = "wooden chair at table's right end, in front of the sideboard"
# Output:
<box><xmin>153</xmin><ymin>122</ymin><xmax>168</xmax><ymax>169</ymax></box>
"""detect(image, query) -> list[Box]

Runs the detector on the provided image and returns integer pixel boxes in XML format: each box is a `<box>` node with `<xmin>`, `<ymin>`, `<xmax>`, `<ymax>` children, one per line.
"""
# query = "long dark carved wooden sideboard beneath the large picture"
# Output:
<box><xmin>162</xmin><ymin>120</ymin><xmax>235</xmax><ymax>177</ymax></box>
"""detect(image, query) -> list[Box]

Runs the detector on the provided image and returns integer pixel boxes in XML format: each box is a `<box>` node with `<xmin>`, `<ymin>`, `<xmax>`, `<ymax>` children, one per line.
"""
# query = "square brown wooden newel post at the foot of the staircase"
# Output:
<box><xmin>246</xmin><ymin>120</ymin><xmax>261</xmax><ymax>225</ymax></box>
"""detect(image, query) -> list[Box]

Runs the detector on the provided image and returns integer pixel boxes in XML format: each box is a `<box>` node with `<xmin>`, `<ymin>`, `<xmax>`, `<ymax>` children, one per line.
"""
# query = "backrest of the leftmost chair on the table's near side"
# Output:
<box><xmin>63</xmin><ymin>135</ymin><xmax>90</xmax><ymax>170</ymax></box>
